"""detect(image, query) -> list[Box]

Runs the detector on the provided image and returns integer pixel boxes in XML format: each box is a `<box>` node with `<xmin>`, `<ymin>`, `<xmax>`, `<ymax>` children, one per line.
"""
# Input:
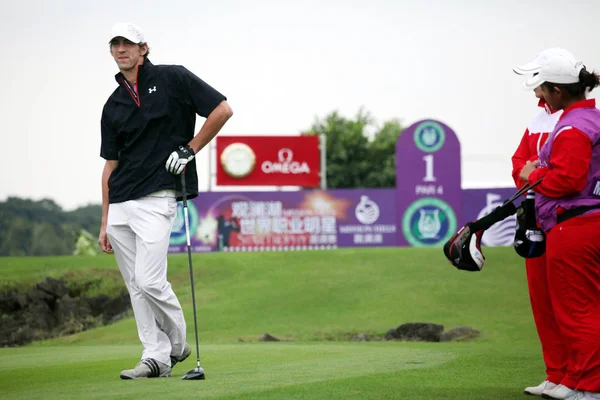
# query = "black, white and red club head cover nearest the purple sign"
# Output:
<box><xmin>444</xmin><ymin>223</ymin><xmax>485</xmax><ymax>272</ymax></box>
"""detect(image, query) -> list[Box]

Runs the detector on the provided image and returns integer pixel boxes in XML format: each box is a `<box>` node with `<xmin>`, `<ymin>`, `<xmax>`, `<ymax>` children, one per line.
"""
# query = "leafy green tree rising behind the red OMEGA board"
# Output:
<box><xmin>305</xmin><ymin>108</ymin><xmax>402</xmax><ymax>189</ymax></box>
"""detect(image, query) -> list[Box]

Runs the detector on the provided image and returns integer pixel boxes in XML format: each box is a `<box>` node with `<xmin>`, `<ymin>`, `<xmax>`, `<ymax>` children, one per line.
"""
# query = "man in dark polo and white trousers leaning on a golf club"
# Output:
<box><xmin>98</xmin><ymin>23</ymin><xmax>233</xmax><ymax>379</ymax></box>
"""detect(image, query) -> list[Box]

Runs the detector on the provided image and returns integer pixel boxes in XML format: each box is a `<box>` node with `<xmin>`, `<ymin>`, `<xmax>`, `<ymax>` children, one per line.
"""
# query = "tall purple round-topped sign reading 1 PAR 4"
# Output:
<box><xmin>396</xmin><ymin>120</ymin><xmax>462</xmax><ymax>247</ymax></box>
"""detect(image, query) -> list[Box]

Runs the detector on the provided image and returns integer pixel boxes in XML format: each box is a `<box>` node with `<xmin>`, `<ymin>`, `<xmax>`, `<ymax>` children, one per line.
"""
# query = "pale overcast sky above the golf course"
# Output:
<box><xmin>0</xmin><ymin>0</ymin><xmax>600</xmax><ymax>209</ymax></box>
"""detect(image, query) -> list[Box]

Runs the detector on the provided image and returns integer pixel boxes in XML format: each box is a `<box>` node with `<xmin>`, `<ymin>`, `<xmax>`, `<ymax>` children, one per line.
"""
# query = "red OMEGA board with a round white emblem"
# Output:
<box><xmin>216</xmin><ymin>135</ymin><xmax>321</xmax><ymax>188</ymax></box>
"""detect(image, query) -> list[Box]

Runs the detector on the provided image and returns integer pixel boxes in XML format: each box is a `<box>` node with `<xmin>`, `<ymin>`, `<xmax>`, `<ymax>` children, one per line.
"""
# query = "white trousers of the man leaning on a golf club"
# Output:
<box><xmin>106</xmin><ymin>190</ymin><xmax>186</xmax><ymax>365</ymax></box>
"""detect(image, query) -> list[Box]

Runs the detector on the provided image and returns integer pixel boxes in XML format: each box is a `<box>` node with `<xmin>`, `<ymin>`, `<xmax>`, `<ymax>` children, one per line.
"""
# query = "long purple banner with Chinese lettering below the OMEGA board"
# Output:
<box><xmin>169</xmin><ymin>189</ymin><xmax>397</xmax><ymax>253</ymax></box>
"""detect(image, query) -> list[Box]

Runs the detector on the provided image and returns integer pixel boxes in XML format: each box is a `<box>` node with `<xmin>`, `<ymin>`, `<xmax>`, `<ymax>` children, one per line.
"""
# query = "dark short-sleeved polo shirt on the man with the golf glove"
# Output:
<box><xmin>100</xmin><ymin>59</ymin><xmax>226</xmax><ymax>203</ymax></box>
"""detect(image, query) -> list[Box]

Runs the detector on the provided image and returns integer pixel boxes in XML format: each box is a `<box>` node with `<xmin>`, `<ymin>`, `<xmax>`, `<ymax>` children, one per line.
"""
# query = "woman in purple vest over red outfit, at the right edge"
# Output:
<box><xmin>519</xmin><ymin>49</ymin><xmax>600</xmax><ymax>400</ymax></box>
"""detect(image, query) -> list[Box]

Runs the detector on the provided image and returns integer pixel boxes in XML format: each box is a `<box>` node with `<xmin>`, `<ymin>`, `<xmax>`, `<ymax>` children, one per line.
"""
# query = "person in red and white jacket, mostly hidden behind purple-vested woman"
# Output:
<box><xmin>512</xmin><ymin>58</ymin><xmax>567</xmax><ymax>396</ymax></box>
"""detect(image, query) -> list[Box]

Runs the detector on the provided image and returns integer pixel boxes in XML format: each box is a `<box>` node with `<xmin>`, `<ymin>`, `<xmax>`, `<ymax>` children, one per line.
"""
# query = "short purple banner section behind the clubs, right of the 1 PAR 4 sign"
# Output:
<box><xmin>460</xmin><ymin>188</ymin><xmax>525</xmax><ymax>246</ymax></box>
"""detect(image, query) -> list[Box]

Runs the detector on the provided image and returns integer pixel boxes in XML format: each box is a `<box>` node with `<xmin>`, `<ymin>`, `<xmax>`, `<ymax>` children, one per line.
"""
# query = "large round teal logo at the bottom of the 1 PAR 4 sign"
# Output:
<box><xmin>402</xmin><ymin>197</ymin><xmax>456</xmax><ymax>247</ymax></box>
